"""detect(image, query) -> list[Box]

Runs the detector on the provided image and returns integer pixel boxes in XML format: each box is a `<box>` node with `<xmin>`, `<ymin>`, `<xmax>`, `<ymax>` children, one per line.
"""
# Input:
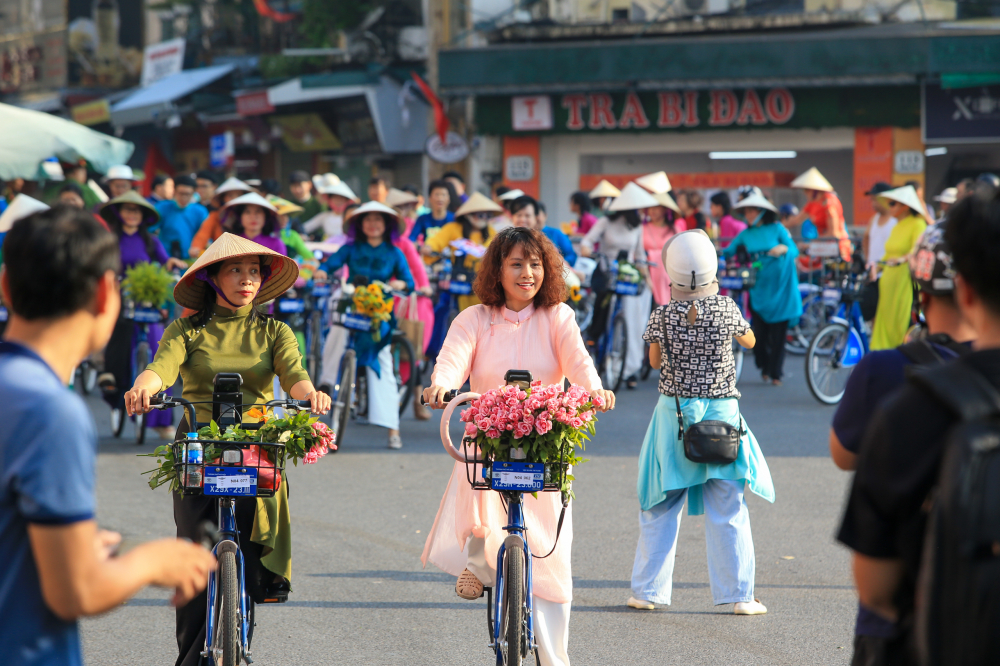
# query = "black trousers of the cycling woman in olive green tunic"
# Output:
<box><xmin>173</xmin><ymin>417</ymin><xmax>268</xmax><ymax>666</ymax></box>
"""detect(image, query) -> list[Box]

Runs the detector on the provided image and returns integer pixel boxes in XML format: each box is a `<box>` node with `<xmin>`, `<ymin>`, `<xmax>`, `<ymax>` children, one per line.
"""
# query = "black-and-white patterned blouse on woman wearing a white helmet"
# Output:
<box><xmin>642</xmin><ymin>295</ymin><xmax>750</xmax><ymax>398</ymax></box>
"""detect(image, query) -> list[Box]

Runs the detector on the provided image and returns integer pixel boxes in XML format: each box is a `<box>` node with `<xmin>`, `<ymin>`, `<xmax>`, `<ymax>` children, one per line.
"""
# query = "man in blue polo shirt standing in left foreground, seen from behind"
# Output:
<box><xmin>0</xmin><ymin>207</ymin><xmax>215</xmax><ymax>666</ymax></box>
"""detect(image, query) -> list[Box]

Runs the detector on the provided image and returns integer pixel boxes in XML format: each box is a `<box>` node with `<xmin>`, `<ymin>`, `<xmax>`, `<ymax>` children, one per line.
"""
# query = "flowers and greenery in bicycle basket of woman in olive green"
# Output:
<box><xmin>140</xmin><ymin>407</ymin><xmax>337</xmax><ymax>490</ymax></box>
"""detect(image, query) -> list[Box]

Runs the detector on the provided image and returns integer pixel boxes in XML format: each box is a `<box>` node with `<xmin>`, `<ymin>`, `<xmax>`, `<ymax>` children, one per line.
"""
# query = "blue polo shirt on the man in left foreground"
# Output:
<box><xmin>0</xmin><ymin>342</ymin><xmax>97</xmax><ymax>666</ymax></box>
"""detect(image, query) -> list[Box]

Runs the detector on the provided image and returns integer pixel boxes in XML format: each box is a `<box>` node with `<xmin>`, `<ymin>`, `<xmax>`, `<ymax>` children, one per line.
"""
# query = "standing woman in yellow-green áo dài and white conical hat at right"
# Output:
<box><xmin>871</xmin><ymin>185</ymin><xmax>927</xmax><ymax>351</ymax></box>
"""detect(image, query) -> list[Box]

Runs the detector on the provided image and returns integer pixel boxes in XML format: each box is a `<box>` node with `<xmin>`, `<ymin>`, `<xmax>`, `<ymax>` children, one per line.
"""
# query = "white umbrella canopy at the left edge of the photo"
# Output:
<box><xmin>0</xmin><ymin>104</ymin><xmax>135</xmax><ymax>180</ymax></box>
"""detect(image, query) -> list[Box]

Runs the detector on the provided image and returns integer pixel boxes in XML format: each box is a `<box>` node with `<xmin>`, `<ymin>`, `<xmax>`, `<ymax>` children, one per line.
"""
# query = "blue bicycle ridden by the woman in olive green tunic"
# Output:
<box><xmin>150</xmin><ymin>386</ymin><xmax>309</xmax><ymax>666</ymax></box>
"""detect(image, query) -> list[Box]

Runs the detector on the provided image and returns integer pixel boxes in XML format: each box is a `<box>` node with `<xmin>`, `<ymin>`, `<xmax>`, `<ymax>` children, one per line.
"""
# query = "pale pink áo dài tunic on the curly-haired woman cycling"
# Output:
<box><xmin>421</xmin><ymin>303</ymin><xmax>601</xmax><ymax>603</ymax></box>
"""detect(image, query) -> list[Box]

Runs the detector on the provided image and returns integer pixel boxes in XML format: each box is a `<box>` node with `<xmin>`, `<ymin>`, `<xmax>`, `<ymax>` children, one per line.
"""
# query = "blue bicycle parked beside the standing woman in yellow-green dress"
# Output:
<box><xmin>805</xmin><ymin>271</ymin><xmax>869</xmax><ymax>405</ymax></box>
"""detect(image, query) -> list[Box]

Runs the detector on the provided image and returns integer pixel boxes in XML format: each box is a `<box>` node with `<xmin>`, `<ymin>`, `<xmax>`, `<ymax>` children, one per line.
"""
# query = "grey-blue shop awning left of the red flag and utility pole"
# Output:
<box><xmin>267</xmin><ymin>71</ymin><xmax>429</xmax><ymax>153</ymax></box>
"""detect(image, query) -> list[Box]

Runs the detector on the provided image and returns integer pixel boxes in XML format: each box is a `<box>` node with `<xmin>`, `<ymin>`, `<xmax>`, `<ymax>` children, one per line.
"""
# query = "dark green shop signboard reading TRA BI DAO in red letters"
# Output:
<box><xmin>476</xmin><ymin>86</ymin><xmax>920</xmax><ymax>135</ymax></box>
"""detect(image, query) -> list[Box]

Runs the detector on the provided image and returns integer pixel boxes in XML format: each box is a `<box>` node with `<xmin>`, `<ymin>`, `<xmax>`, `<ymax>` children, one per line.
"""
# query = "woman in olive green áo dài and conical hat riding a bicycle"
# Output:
<box><xmin>125</xmin><ymin>233</ymin><xmax>330</xmax><ymax>666</ymax></box>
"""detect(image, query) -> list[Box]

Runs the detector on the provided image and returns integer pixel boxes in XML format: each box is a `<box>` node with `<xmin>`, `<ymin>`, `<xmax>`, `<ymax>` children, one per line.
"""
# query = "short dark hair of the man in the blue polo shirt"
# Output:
<box><xmin>3</xmin><ymin>206</ymin><xmax>121</xmax><ymax>321</ymax></box>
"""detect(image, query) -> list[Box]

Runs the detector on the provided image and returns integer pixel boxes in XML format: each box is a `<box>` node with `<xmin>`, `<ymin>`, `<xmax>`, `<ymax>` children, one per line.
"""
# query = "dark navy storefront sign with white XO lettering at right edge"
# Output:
<box><xmin>923</xmin><ymin>83</ymin><xmax>1000</xmax><ymax>143</ymax></box>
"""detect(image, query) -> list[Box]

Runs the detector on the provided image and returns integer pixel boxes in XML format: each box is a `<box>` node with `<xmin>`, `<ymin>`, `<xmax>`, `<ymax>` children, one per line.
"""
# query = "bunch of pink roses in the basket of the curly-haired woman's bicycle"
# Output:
<box><xmin>461</xmin><ymin>381</ymin><xmax>604</xmax><ymax>493</ymax></box>
